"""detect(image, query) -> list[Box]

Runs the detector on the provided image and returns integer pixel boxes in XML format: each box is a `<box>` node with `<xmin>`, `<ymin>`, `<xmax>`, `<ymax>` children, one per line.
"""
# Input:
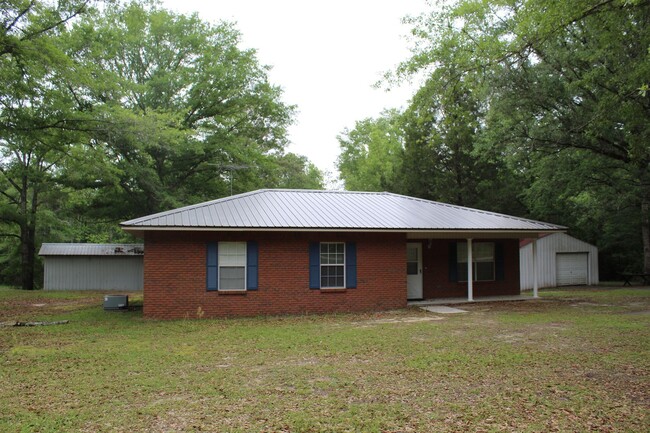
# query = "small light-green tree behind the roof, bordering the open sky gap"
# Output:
<box><xmin>337</xmin><ymin>110</ymin><xmax>404</xmax><ymax>191</ymax></box>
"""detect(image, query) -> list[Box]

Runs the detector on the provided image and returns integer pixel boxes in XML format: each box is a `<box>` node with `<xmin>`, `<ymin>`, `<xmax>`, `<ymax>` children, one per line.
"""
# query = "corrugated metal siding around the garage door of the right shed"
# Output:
<box><xmin>519</xmin><ymin>233</ymin><xmax>599</xmax><ymax>290</ymax></box>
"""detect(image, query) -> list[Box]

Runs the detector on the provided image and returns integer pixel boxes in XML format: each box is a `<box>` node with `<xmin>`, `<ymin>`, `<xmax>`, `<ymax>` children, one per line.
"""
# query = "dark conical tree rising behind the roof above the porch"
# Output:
<box><xmin>401</xmin><ymin>66</ymin><xmax>524</xmax><ymax>214</ymax></box>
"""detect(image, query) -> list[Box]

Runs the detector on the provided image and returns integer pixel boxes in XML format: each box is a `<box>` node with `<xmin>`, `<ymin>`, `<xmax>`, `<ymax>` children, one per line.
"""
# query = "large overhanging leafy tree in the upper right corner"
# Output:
<box><xmin>399</xmin><ymin>0</ymin><xmax>650</xmax><ymax>272</ymax></box>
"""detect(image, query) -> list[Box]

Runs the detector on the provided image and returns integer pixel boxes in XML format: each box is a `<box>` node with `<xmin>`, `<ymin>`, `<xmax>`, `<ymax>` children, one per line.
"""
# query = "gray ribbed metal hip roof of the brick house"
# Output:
<box><xmin>121</xmin><ymin>189</ymin><xmax>565</xmax><ymax>232</ymax></box>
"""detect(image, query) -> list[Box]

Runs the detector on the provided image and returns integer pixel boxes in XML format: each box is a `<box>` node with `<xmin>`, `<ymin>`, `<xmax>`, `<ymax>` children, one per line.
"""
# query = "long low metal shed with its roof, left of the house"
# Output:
<box><xmin>38</xmin><ymin>243</ymin><xmax>144</xmax><ymax>291</ymax></box>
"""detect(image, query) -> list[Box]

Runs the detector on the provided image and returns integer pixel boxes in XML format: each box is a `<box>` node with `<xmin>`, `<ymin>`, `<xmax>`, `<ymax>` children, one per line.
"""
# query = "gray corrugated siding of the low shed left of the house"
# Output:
<box><xmin>43</xmin><ymin>256</ymin><xmax>144</xmax><ymax>291</ymax></box>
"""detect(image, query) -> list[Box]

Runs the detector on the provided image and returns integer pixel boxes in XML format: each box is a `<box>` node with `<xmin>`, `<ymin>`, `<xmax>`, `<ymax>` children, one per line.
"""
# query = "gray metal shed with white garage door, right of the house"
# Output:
<box><xmin>519</xmin><ymin>233</ymin><xmax>598</xmax><ymax>290</ymax></box>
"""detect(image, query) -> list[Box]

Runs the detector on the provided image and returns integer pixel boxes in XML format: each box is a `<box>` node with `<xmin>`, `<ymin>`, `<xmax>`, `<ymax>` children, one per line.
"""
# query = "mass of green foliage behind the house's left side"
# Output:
<box><xmin>0</xmin><ymin>0</ymin><xmax>323</xmax><ymax>288</ymax></box>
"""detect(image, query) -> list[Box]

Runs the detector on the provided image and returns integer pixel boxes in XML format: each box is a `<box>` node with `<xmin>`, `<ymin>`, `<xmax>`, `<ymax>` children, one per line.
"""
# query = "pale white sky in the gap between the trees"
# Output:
<box><xmin>162</xmin><ymin>0</ymin><xmax>426</xmax><ymax>181</ymax></box>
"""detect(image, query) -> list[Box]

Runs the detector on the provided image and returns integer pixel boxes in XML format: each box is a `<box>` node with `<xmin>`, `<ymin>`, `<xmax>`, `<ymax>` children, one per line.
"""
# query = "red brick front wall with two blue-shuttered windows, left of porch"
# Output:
<box><xmin>144</xmin><ymin>232</ymin><xmax>406</xmax><ymax>319</ymax></box>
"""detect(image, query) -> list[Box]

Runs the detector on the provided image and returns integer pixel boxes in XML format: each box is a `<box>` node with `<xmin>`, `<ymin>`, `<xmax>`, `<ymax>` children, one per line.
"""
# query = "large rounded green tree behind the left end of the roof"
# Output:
<box><xmin>60</xmin><ymin>2</ymin><xmax>293</xmax><ymax>218</ymax></box>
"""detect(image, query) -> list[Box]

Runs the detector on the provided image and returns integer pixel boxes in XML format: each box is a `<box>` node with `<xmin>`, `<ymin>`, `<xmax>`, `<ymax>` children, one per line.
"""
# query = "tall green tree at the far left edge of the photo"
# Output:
<box><xmin>0</xmin><ymin>0</ymin><xmax>89</xmax><ymax>289</ymax></box>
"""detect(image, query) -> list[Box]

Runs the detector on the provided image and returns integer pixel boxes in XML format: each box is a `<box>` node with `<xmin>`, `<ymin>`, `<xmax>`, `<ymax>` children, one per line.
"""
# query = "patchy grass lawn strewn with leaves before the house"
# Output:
<box><xmin>0</xmin><ymin>288</ymin><xmax>650</xmax><ymax>432</ymax></box>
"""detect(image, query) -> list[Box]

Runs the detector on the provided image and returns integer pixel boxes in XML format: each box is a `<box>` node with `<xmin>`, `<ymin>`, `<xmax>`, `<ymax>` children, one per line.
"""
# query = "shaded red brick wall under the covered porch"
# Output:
<box><xmin>418</xmin><ymin>239</ymin><xmax>519</xmax><ymax>299</ymax></box>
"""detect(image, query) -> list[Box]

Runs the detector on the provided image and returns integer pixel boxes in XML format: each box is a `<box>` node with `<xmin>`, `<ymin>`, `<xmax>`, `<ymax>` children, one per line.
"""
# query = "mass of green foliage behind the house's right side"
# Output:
<box><xmin>384</xmin><ymin>0</ymin><xmax>650</xmax><ymax>271</ymax></box>
